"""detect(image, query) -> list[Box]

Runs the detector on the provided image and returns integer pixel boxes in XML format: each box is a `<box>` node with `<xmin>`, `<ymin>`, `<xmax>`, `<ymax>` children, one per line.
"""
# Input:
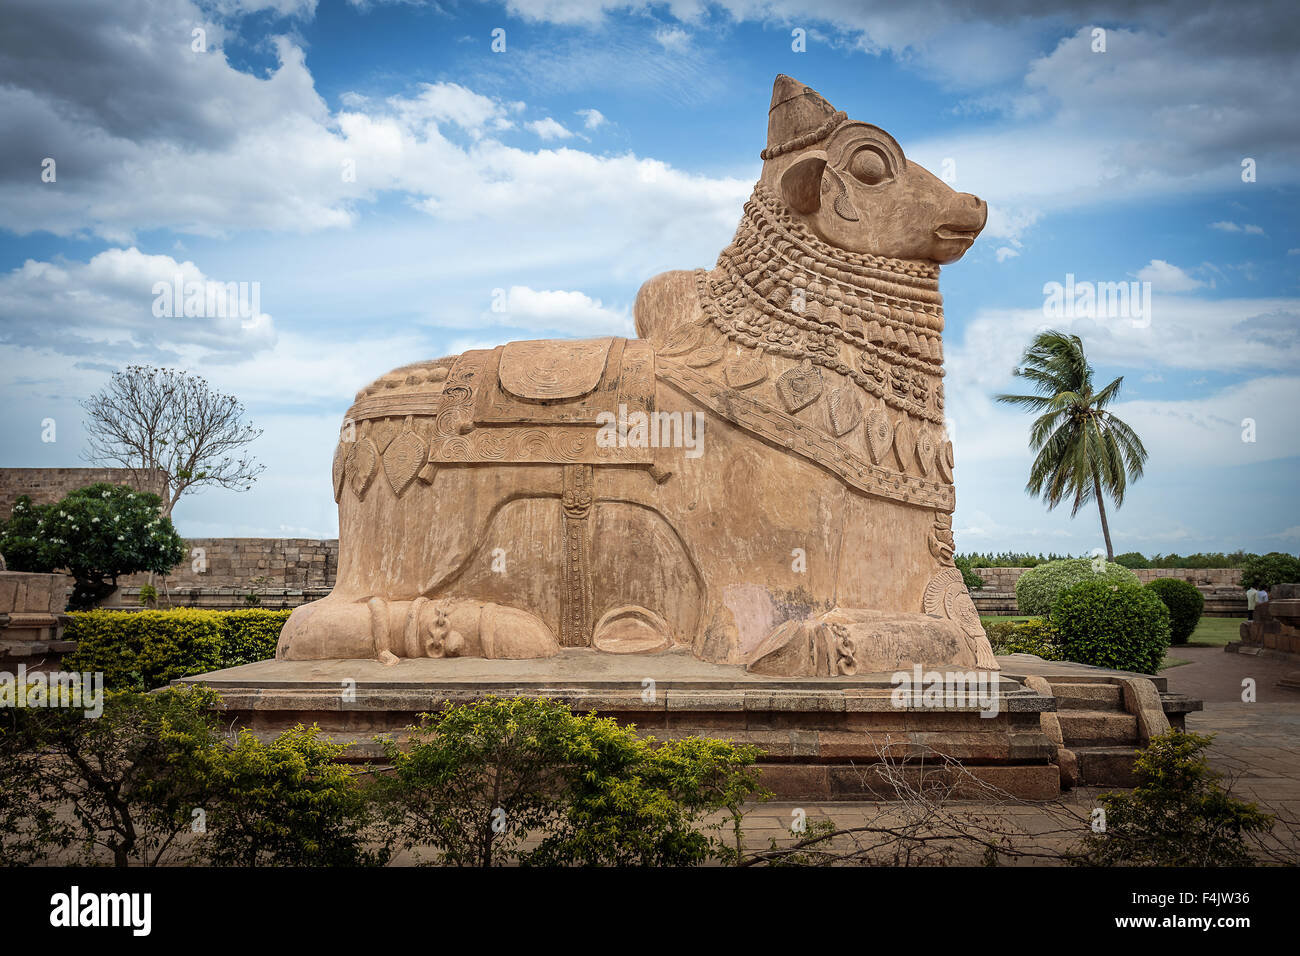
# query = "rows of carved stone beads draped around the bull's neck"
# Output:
<box><xmin>696</xmin><ymin>182</ymin><xmax>944</xmax><ymax>424</ymax></box>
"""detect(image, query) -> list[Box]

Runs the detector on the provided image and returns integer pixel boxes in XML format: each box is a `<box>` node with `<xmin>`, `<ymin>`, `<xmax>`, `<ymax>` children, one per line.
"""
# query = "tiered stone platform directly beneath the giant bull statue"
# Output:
<box><xmin>176</xmin><ymin>649</ymin><xmax>1199</xmax><ymax>800</ymax></box>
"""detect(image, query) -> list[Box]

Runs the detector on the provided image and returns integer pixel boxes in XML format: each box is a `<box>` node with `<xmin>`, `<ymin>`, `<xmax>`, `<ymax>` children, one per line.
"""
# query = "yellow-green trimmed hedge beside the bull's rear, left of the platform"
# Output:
<box><xmin>64</xmin><ymin>607</ymin><xmax>290</xmax><ymax>691</ymax></box>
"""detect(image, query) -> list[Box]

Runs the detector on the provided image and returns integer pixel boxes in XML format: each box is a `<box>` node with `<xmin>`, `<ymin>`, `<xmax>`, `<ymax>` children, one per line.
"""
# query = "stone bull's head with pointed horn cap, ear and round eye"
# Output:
<box><xmin>763</xmin><ymin>74</ymin><xmax>988</xmax><ymax>264</ymax></box>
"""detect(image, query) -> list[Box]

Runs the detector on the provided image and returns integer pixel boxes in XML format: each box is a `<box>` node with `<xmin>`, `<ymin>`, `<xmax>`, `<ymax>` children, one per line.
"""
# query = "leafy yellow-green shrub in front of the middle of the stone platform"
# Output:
<box><xmin>384</xmin><ymin>697</ymin><xmax>768</xmax><ymax>866</ymax></box>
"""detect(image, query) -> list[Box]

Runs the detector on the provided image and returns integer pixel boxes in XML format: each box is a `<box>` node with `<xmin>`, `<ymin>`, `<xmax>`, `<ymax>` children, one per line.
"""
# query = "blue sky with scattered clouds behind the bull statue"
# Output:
<box><xmin>0</xmin><ymin>0</ymin><xmax>1300</xmax><ymax>553</ymax></box>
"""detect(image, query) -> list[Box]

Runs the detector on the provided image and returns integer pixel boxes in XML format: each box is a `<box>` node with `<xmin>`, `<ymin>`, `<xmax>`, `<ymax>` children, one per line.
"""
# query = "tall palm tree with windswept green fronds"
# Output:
<box><xmin>997</xmin><ymin>332</ymin><xmax>1147</xmax><ymax>561</ymax></box>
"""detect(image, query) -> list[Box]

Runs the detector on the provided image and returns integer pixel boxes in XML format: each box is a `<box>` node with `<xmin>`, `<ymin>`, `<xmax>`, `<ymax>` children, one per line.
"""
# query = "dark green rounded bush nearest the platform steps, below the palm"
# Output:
<box><xmin>1052</xmin><ymin>576</ymin><xmax>1170</xmax><ymax>674</ymax></box>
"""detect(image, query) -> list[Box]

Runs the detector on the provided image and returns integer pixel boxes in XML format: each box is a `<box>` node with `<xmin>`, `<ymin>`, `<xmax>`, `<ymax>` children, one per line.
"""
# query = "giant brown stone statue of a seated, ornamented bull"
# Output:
<box><xmin>277</xmin><ymin>75</ymin><xmax>997</xmax><ymax>676</ymax></box>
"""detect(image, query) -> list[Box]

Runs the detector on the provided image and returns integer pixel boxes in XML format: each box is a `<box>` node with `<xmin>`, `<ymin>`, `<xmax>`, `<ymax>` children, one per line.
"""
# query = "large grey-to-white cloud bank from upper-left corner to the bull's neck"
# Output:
<box><xmin>0</xmin><ymin>0</ymin><xmax>757</xmax><ymax>254</ymax></box>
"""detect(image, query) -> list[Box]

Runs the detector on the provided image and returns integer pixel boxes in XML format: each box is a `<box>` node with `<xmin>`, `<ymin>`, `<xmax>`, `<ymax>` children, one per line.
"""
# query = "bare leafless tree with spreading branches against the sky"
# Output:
<box><xmin>82</xmin><ymin>365</ymin><xmax>265</xmax><ymax>516</ymax></box>
